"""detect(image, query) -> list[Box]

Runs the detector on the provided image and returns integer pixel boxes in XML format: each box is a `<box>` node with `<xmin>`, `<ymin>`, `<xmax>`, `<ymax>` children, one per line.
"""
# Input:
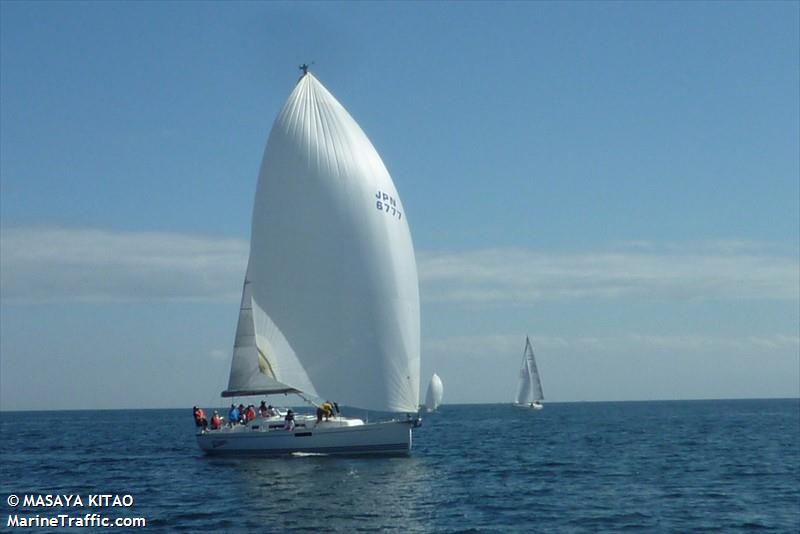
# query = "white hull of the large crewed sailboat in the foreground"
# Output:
<box><xmin>197</xmin><ymin>417</ymin><xmax>418</xmax><ymax>456</ymax></box>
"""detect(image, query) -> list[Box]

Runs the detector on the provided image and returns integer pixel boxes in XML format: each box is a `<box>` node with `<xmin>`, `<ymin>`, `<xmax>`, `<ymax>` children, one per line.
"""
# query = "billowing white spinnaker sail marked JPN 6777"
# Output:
<box><xmin>229</xmin><ymin>74</ymin><xmax>420</xmax><ymax>412</ymax></box>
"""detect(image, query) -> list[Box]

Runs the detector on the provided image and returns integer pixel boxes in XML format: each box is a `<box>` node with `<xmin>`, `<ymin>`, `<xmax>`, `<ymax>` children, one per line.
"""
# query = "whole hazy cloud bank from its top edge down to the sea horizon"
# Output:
<box><xmin>0</xmin><ymin>227</ymin><xmax>800</xmax><ymax>409</ymax></box>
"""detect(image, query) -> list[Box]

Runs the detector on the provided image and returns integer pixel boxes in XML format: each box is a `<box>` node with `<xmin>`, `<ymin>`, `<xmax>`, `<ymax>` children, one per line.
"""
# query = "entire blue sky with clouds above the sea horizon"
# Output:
<box><xmin>0</xmin><ymin>2</ymin><xmax>800</xmax><ymax>410</ymax></box>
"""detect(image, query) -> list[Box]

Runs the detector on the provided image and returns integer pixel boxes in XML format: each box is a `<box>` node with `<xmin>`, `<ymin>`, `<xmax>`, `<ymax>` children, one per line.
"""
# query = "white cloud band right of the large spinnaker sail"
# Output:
<box><xmin>417</xmin><ymin>242</ymin><xmax>800</xmax><ymax>304</ymax></box>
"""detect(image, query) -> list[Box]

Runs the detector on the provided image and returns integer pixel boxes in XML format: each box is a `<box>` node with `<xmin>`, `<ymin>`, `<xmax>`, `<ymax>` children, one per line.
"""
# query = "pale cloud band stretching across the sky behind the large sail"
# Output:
<box><xmin>0</xmin><ymin>228</ymin><xmax>800</xmax><ymax>305</ymax></box>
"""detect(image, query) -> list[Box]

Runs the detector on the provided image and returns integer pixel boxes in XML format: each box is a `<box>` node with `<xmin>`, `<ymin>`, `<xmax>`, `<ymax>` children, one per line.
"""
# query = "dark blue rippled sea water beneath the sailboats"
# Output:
<box><xmin>0</xmin><ymin>399</ymin><xmax>800</xmax><ymax>533</ymax></box>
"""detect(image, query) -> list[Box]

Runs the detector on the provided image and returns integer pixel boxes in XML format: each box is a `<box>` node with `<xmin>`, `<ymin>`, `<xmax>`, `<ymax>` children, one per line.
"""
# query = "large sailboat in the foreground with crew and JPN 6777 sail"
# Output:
<box><xmin>197</xmin><ymin>65</ymin><xmax>420</xmax><ymax>455</ymax></box>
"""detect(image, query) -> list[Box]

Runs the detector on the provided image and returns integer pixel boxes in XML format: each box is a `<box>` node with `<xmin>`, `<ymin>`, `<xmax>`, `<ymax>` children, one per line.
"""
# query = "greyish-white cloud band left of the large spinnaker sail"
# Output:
<box><xmin>0</xmin><ymin>228</ymin><xmax>248</xmax><ymax>302</ymax></box>
